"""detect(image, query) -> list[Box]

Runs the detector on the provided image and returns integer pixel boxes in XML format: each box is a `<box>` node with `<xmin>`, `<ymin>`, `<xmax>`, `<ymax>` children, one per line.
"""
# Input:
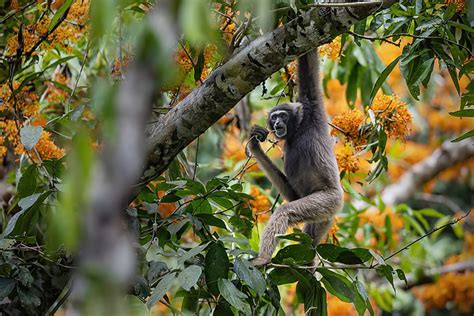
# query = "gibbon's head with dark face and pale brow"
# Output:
<box><xmin>268</xmin><ymin>103</ymin><xmax>303</xmax><ymax>139</ymax></box>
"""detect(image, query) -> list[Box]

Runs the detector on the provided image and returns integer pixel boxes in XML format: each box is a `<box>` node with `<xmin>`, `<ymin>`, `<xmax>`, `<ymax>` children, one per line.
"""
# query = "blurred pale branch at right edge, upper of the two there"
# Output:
<box><xmin>382</xmin><ymin>138</ymin><xmax>474</xmax><ymax>204</ymax></box>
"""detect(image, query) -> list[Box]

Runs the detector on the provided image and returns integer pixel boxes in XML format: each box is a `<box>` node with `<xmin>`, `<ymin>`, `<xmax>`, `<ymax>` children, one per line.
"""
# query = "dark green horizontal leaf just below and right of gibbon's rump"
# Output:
<box><xmin>316</xmin><ymin>244</ymin><xmax>372</xmax><ymax>264</ymax></box>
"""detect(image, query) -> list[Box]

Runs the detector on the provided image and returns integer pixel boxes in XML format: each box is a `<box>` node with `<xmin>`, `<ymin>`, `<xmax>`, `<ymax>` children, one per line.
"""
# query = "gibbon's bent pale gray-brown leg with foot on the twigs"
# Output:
<box><xmin>252</xmin><ymin>188</ymin><xmax>342</xmax><ymax>265</ymax></box>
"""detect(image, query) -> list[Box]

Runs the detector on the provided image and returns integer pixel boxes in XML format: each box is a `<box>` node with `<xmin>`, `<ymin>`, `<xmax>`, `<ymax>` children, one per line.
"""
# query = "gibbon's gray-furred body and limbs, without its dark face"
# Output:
<box><xmin>250</xmin><ymin>52</ymin><xmax>343</xmax><ymax>265</ymax></box>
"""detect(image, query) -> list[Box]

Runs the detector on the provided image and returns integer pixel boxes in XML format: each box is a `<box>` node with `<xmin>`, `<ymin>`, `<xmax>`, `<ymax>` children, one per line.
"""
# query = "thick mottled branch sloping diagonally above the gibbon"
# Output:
<box><xmin>147</xmin><ymin>0</ymin><xmax>396</xmax><ymax>178</ymax></box>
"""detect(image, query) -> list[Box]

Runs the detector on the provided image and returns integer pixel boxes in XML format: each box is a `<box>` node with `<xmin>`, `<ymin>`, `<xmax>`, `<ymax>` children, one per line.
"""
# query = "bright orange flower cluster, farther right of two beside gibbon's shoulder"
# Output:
<box><xmin>371</xmin><ymin>94</ymin><xmax>412</xmax><ymax>139</ymax></box>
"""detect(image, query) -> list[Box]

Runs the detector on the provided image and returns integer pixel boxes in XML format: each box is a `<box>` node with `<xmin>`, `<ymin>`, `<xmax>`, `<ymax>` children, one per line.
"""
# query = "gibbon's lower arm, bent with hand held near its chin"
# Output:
<box><xmin>249</xmin><ymin>135</ymin><xmax>299</xmax><ymax>201</ymax></box>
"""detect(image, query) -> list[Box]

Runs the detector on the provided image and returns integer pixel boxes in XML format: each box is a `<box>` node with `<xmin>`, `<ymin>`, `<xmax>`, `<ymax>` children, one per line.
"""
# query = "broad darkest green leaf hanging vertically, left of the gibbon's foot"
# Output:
<box><xmin>204</xmin><ymin>242</ymin><xmax>230</xmax><ymax>295</ymax></box>
